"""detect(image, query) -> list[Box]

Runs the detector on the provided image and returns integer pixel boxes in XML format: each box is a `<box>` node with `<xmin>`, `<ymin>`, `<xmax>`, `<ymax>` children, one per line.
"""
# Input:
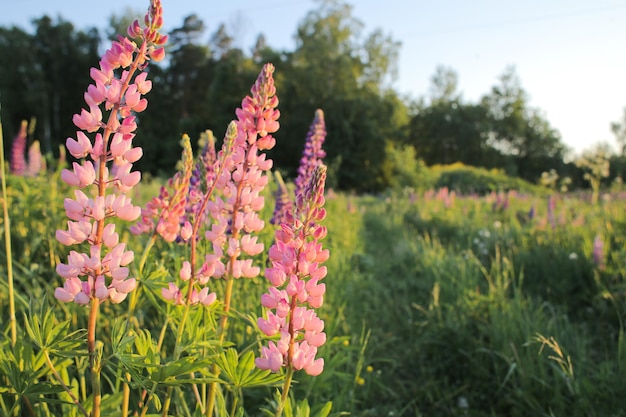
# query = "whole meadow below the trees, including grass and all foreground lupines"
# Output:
<box><xmin>0</xmin><ymin>0</ymin><xmax>626</xmax><ymax>417</ymax></box>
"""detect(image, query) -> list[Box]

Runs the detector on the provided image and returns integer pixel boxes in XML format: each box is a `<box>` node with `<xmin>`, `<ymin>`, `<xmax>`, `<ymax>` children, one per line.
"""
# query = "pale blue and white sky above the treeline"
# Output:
<box><xmin>0</xmin><ymin>0</ymin><xmax>626</xmax><ymax>153</ymax></box>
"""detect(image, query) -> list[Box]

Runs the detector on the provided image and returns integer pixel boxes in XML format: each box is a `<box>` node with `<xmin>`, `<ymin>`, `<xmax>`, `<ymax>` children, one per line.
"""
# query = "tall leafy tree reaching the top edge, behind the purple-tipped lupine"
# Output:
<box><xmin>272</xmin><ymin>1</ymin><xmax>408</xmax><ymax>190</ymax></box>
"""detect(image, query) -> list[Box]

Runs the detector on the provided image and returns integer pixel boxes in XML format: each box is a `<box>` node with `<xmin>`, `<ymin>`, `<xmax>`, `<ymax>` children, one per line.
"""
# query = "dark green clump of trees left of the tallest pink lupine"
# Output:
<box><xmin>0</xmin><ymin>16</ymin><xmax>100</xmax><ymax>153</ymax></box>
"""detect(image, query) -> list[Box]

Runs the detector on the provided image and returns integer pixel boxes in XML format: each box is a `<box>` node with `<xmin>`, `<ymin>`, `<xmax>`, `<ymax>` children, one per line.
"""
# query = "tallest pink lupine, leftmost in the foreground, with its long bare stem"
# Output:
<box><xmin>55</xmin><ymin>0</ymin><xmax>167</xmax><ymax>417</ymax></box>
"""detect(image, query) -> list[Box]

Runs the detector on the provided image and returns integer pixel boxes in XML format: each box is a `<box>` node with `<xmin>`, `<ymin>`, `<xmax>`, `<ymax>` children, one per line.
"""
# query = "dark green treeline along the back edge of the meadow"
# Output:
<box><xmin>0</xmin><ymin>1</ymin><xmax>604</xmax><ymax>191</ymax></box>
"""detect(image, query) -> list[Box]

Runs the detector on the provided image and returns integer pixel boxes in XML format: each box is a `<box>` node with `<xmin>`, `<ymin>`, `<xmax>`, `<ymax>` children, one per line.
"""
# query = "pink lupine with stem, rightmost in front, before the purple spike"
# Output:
<box><xmin>255</xmin><ymin>164</ymin><xmax>329</xmax><ymax>417</ymax></box>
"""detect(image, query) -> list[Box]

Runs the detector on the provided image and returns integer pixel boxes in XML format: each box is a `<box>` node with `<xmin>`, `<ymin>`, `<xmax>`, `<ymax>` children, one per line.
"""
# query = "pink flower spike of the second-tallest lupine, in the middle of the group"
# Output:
<box><xmin>203</xmin><ymin>64</ymin><xmax>280</xmax><ymax>278</ymax></box>
